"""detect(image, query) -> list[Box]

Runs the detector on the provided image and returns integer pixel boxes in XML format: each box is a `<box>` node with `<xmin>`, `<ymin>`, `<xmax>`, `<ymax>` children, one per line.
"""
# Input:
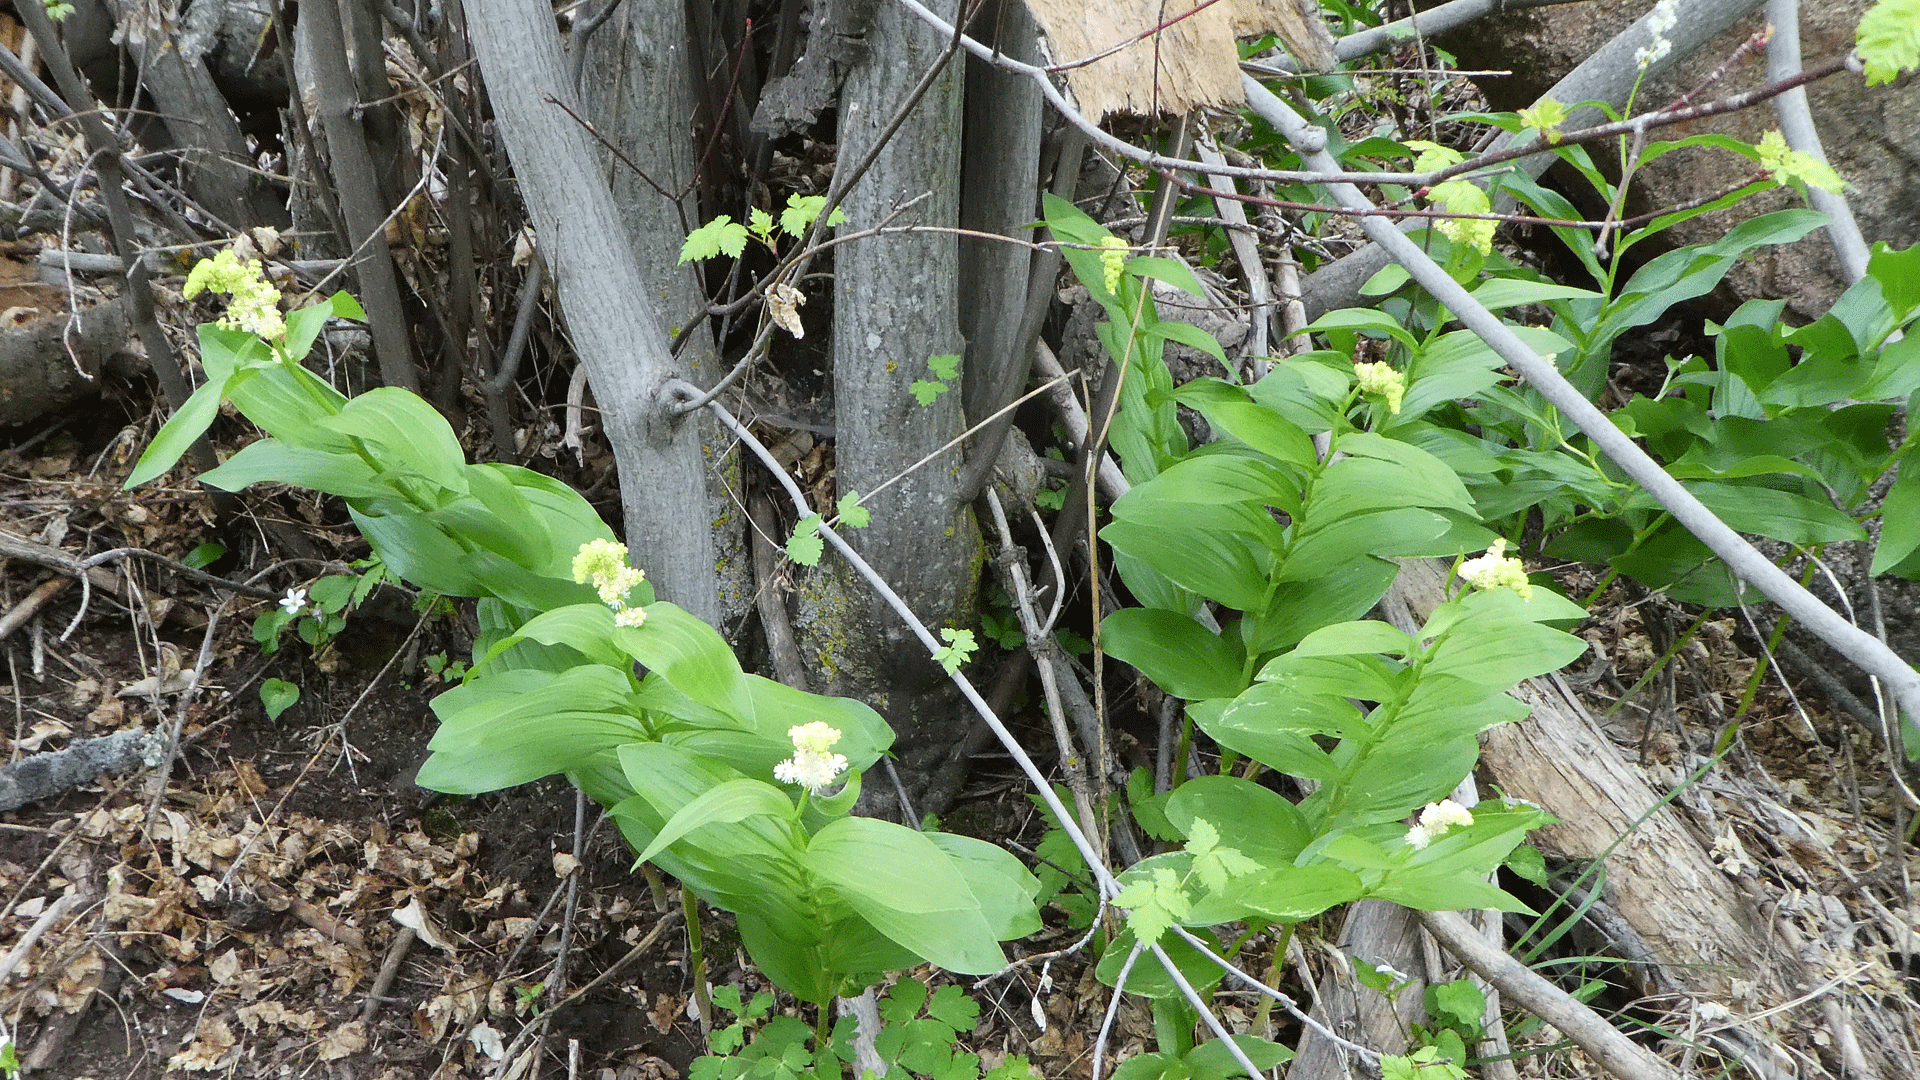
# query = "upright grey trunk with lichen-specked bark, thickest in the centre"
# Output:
<box><xmin>803</xmin><ymin>2</ymin><xmax>981</xmax><ymax>799</ymax></box>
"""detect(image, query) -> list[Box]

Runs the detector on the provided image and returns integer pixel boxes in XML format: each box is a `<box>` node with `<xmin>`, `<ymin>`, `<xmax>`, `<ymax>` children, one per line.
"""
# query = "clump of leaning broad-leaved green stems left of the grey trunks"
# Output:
<box><xmin>129</xmin><ymin>247</ymin><xmax>1039</xmax><ymax>1017</ymax></box>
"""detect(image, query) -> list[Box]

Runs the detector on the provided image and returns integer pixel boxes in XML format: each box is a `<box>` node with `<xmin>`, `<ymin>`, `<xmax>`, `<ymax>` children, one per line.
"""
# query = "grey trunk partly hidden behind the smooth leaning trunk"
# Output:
<box><xmin>572</xmin><ymin>4</ymin><xmax>748</xmax><ymax>625</ymax></box>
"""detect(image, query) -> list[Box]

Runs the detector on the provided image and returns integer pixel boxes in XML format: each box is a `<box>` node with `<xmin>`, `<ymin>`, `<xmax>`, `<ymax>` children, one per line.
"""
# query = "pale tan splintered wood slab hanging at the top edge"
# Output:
<box><xmin>1027</xmin><ymin>0</ymin><xmax>1334</xmax><ymax>123</ymax></box>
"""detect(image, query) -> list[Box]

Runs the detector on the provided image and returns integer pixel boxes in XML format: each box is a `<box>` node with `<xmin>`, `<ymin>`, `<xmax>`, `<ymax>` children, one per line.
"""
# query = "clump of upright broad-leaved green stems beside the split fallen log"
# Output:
<box><xmin>1048</xmin><ymin>202</ymin><xmax>1586</xmax><ymax>1014</ymax></box>
